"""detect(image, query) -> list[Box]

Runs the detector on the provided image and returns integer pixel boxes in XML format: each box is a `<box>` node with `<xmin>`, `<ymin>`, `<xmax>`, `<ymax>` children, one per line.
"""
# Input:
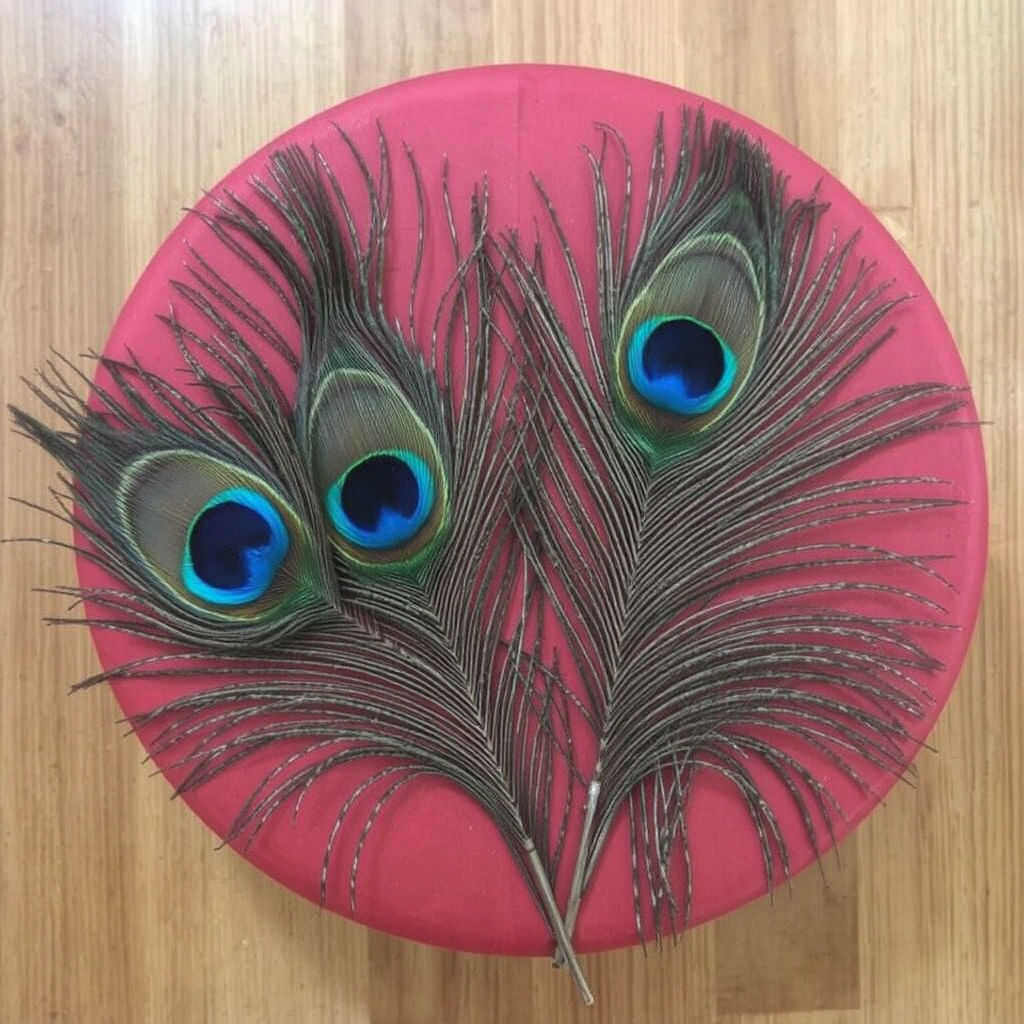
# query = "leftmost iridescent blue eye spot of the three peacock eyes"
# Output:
<box><xmin>181</xmin><ymin>487</ymin><xmax>289</xmax><ymax>605</ymax></box>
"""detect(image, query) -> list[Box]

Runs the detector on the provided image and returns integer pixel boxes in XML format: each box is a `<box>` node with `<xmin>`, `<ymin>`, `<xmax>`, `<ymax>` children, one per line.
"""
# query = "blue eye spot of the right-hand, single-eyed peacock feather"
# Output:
<box><xmin>627</xmin><ymin>316</ymin><xmax>736</xmax><ymax>416</ymax></box>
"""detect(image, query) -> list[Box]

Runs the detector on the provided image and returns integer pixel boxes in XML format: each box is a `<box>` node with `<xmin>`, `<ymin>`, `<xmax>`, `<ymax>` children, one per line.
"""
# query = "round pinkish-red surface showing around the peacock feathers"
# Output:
<box><xmin>79</xmin><ymin>66</ymin><xmax>986</xmax><ymax>954</ymax></box>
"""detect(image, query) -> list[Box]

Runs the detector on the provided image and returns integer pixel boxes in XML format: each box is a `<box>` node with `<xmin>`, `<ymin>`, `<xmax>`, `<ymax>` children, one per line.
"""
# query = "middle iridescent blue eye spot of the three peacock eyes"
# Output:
<box><xmin>327</xmin><ymin>449</ymin><xmax>435</xmax><ymax>551</ymax></box>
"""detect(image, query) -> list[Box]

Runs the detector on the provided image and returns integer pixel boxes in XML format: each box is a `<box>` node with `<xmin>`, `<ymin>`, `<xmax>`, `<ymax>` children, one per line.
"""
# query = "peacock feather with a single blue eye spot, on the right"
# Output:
<box><xmin>496</xmin><ymin>113</ymin><xmax>965</xmax><ymax>940</ymax></box>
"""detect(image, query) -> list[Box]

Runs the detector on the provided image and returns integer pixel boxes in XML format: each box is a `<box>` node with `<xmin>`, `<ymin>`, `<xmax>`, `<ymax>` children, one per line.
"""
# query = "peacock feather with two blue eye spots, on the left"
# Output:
<box><xmin>13</xmin><ymin>129</ymin><xmax>590</xmax><ymax>1000</ymax></box>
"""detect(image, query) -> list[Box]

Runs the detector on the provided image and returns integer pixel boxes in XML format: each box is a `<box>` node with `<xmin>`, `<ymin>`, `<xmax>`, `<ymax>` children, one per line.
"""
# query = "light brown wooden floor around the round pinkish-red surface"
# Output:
<box><xmin>0</xmin><ymin>0</ymin><xmax>1024</xmax><ymax>1024</ymax></box>
